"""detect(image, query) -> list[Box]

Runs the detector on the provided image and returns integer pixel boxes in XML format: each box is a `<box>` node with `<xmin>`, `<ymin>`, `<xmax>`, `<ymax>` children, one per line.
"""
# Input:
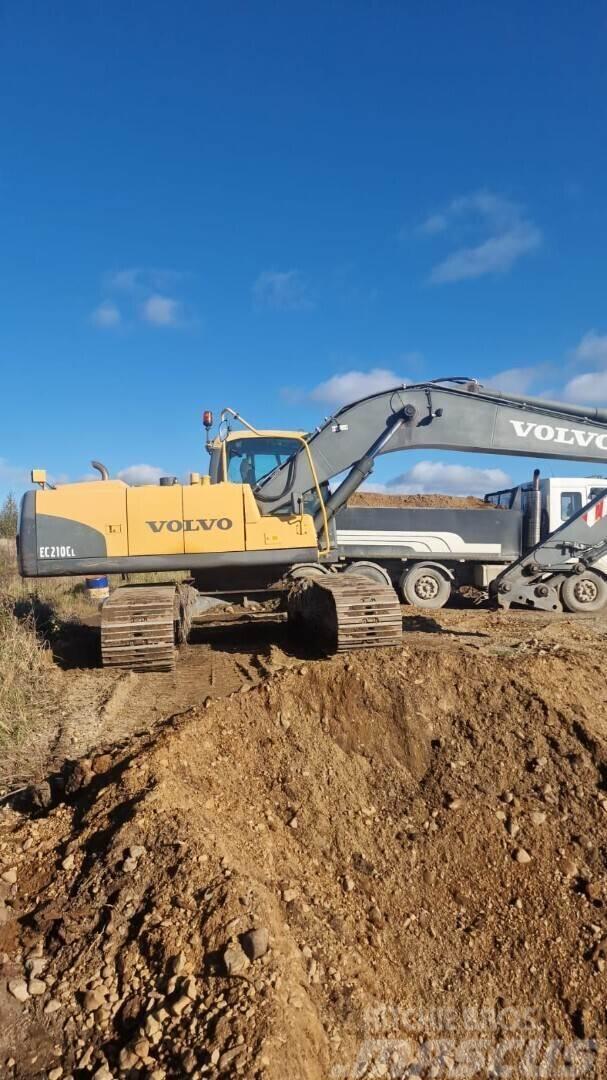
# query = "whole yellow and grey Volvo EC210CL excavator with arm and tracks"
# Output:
<box><xmin>18</xmin><ymin>378</ymin><xmax>607</xmax><ymax>671</ymax></box>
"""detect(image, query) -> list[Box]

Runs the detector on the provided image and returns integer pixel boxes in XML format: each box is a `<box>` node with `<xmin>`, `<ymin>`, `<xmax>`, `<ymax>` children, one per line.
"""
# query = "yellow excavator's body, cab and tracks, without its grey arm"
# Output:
<box><xmin>17</xmin><ymin>401</ymin><xmax>402</xmax><ymax>671</ymax></box>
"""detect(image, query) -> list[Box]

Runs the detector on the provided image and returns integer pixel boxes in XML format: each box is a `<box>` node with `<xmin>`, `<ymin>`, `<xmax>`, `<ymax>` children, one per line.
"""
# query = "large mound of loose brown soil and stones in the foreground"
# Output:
<box><xmin>0</xmin><ymin>609</ymin><xmax>607</xmax><ymax>1080</ymax></box>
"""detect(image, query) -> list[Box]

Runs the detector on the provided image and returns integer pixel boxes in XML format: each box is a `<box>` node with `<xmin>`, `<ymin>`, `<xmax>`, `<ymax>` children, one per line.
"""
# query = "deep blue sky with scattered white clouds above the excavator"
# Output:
<box><xmin>0</xmin><ymin>0</ymin><xmax>607</xmax><ymax>495</ymax></box>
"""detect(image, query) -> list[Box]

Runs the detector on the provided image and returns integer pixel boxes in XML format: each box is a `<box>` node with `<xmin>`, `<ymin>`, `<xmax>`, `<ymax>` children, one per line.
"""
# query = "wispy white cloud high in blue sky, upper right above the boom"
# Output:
<box><xmin>420</xmin><ymin>191</ymin><xmax>542</xmax><ymax>285</ymax></box>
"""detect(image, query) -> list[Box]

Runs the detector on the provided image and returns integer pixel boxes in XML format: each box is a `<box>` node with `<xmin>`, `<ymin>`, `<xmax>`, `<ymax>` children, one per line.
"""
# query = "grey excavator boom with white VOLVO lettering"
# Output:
<box><xmin>255</xmin><ymin>378</ymin><xmax>607</xmax><ymax>526</ymax></box>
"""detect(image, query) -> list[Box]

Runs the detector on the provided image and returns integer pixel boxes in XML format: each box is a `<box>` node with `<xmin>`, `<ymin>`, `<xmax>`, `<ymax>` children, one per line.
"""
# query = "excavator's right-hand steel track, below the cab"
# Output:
<box><xmin>288</xmin><ymin>573</ymin><xmax>403</xmax><ymax>652</ymax></box>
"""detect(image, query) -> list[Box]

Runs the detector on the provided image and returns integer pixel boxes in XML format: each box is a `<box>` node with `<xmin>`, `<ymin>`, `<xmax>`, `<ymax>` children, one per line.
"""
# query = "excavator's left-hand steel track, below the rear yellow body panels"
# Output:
<box><xmin>102</xmin><ymin>585</ymin><xmax>183</xmax><ymax>672</ymax></box>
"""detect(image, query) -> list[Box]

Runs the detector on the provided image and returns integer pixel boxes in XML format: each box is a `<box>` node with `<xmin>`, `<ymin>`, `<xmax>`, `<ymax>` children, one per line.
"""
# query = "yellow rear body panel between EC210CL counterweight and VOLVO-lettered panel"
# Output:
<box><xmin>36</xmin><ymin>480</ymin><xmax>128</xmax><ymax>557</ymax></box>
